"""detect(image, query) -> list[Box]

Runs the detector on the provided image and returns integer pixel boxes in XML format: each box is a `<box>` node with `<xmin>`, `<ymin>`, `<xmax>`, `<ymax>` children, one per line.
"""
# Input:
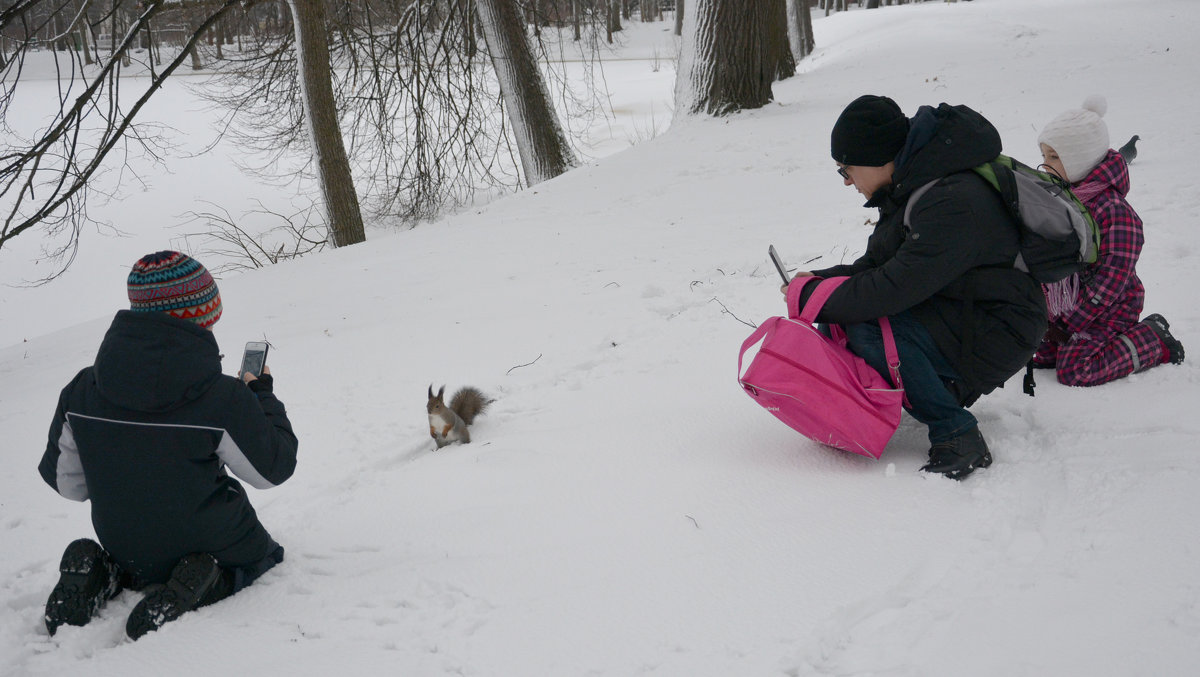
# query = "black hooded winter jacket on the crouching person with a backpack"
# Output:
<box><xmin>797</xmin><ymin>103</ymin><xmax>1046</xmax><ymax>403</ymax></box>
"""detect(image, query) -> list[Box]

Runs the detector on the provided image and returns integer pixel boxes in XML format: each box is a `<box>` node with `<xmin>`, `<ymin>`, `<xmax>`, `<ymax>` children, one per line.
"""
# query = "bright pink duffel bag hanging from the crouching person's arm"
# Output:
<box><xmin>738</xmin><ymin>277</ymin><xmax>904</xmax><ymax>459</ymax></box>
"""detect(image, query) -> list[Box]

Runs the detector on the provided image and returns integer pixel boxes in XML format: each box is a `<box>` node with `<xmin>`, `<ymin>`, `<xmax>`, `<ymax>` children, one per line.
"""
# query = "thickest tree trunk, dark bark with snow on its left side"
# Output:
<box><xmin>676</xmin><ymin>0</ymin><xmax>777</xmax><ymax>115</ymax></box>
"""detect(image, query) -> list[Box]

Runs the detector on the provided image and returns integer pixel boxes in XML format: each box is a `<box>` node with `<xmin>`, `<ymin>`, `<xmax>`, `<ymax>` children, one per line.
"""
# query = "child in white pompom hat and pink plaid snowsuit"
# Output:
<box><xmin>1033</xmin><ymin>96</ymin><xmax>1183</xmax><ymax>385</ymax></box>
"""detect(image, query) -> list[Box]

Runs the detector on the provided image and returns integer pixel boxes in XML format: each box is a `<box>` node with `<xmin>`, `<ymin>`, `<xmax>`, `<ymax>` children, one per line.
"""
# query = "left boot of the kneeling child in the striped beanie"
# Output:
<box><xmin>46</xmin><ymin>538</ymin><xmax>121</xmax><ymax>635</ymax></box>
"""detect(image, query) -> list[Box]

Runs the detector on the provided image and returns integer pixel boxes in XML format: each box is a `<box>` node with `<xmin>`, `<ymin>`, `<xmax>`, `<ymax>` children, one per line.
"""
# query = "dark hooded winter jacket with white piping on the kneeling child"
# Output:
<box><xmin>38</xmin><ymin>311</ymin><xmax>296</xmax><ymax>585</ymax></box>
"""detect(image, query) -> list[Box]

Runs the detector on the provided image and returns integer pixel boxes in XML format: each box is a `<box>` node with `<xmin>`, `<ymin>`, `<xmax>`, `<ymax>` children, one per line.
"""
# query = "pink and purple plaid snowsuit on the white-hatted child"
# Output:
<box><xmin>1033</xmin><ymin>150</ymin><xmax>1166</xmax><ymax>385</ymax></box>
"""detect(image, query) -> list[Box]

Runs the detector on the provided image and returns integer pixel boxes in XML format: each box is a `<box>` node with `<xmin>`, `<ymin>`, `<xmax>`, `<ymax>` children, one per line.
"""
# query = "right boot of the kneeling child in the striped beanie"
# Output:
<box><xmin>125</xmin><ymin>552</ymin><xmax>222</xmax><ymax>640</ymax></box>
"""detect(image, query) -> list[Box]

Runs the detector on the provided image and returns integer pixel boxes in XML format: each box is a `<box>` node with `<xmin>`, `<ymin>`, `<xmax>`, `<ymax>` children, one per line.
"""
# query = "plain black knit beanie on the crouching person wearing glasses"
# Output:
<box><xmin>829</xmin><ymin>94</ymin><xmax>908</xmax><ymax>167</ymax></box>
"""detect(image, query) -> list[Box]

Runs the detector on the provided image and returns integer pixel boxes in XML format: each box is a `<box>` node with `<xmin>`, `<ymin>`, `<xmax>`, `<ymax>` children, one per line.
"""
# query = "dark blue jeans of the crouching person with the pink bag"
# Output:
<box><xmin>844</xmin><ymin>312</ymin><xmax>978</xmax><ymax>444</ymax></box>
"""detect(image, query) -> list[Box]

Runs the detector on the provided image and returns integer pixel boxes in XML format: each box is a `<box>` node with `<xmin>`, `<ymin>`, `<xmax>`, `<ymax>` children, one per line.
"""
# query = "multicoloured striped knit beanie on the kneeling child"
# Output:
<box><xmin>127</xmin><ymin>251</ymin><xmax>221</xmax><ymax>328</ymax></box>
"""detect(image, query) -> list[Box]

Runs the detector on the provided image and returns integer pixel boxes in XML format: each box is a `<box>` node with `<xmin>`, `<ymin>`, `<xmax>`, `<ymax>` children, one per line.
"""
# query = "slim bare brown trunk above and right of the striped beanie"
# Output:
<box><xmin>288</xmin><ymin>0</ymin><xmax>366</xmax><ymax>247</ymax></box>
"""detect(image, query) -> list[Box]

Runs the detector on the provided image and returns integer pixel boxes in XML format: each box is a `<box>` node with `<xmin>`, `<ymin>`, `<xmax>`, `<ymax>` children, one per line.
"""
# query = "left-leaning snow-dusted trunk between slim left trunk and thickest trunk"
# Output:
<box><xmin>478</xmin><ymin>0</ymin><xmax>575</xmax><ymax>186</ymax></box>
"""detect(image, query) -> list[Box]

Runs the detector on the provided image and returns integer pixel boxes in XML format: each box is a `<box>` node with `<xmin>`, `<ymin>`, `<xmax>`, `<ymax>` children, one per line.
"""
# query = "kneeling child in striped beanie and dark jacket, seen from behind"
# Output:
<box><xmin>38</xmin><ymin>251</ymin><xmax>296</xmax><ymax>640</ymax></box>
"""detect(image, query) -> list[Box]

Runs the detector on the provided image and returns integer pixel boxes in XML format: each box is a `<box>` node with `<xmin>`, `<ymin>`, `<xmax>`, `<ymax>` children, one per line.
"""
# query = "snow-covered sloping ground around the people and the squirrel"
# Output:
<box><xmin>0</xmin><ymin>0</ymin><xmax>1200</xmax><ymax>677</ymax></box>
